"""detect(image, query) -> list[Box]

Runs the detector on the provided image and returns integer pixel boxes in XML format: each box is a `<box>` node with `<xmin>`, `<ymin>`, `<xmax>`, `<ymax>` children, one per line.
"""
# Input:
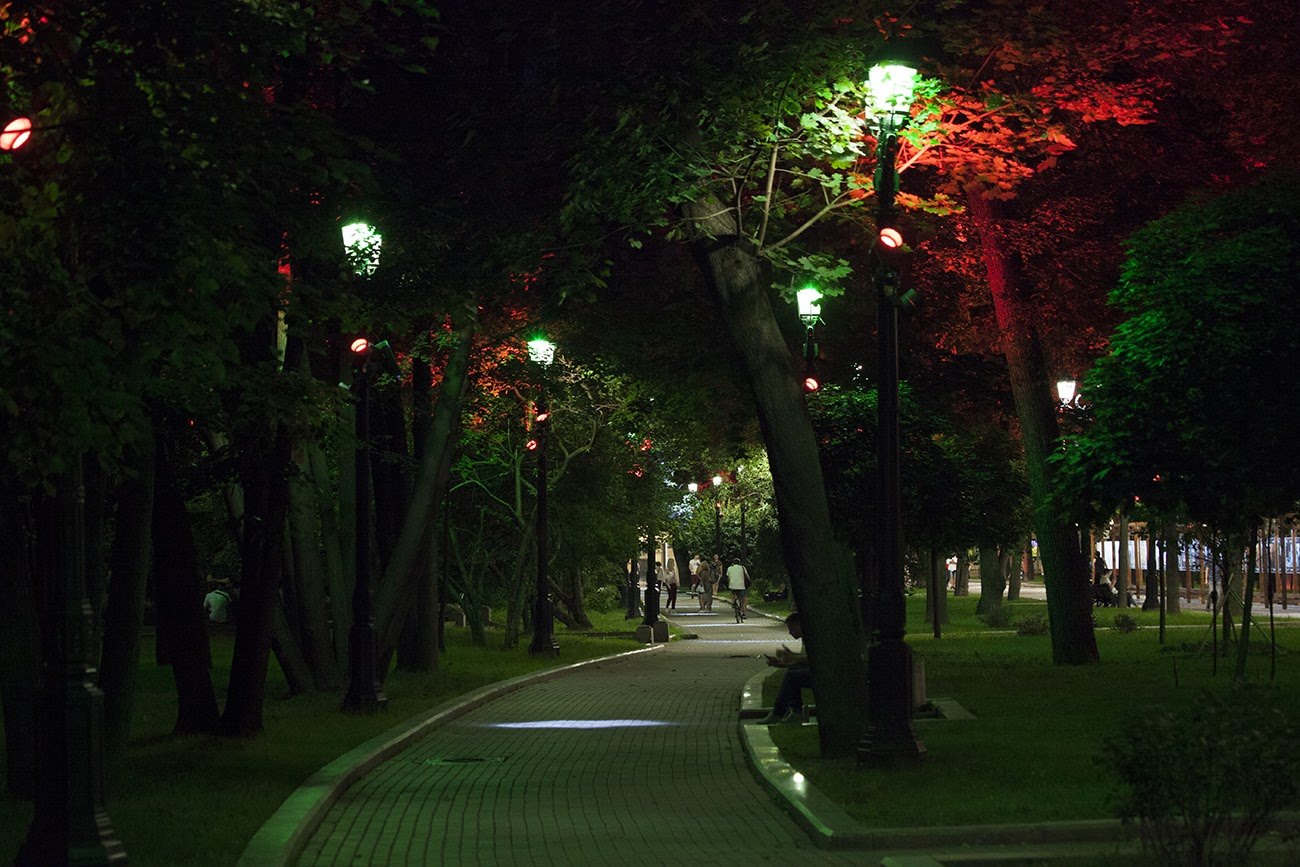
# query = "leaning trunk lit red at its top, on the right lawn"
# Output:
<box><xmin>966</xmin><ymin>185</ymin><xmax>1100</xmax><ymax>664</ymax></box>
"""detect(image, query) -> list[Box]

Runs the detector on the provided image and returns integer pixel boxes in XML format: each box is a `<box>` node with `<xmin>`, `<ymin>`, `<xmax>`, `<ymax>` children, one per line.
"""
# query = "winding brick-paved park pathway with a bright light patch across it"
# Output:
<box><xmin>298</xmin><ymin>597</ymin><xmax>861</xmax><ymax>864</ymax></box>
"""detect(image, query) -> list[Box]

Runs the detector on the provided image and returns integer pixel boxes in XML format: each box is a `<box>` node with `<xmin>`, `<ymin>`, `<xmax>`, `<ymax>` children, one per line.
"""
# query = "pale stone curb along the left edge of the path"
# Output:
<box><xmin>237</xmin><ymin>645</ymin><xmax>667</xmax><ymax>867</ymax></box>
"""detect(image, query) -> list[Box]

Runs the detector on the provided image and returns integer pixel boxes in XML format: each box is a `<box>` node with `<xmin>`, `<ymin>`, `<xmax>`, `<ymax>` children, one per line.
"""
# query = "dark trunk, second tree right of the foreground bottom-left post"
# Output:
<box><xmin>152</xmin><ymin>430</ymin><xmax>218</xmax><ymax>733</ymax></box>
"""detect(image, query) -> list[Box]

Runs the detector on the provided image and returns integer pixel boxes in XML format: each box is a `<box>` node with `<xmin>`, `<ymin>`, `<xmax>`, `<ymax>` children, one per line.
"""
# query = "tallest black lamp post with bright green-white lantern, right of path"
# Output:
<box><xmin>858</xmin><ymin>53</ymin><xmax>926</xmax><ymax>764</ymax></box>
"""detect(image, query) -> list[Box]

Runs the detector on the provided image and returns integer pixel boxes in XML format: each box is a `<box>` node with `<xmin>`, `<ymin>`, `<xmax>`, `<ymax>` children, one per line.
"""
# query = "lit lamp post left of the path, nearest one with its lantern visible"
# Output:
<box><xmin>343</xmin><ymin>222</ymin><xmax>389</xmax><ymax>714</ymax></box>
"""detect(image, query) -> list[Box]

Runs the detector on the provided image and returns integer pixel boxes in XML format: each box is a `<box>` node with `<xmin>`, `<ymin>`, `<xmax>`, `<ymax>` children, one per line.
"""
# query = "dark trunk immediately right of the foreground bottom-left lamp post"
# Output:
<box><xmin>99</xmin><ymin>437</ymin><xmax>156</xmax><ymax>775</ymax></box>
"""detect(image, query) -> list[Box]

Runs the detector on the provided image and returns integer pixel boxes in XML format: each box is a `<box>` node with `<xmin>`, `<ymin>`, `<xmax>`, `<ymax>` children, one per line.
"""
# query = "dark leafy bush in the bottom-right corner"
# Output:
<box><xmin>1099</xmin><ymin>686</ymin><xmax>1300</xmax><ymax>864</ymax></box>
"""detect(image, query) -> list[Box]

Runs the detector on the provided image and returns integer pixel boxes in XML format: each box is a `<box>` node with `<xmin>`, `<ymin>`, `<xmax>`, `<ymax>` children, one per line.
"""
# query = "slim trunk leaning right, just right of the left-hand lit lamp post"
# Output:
<box><xmin>374</xmin><ymin>318</ymin><xmax>477</xmax><ymax>656</ymax></box>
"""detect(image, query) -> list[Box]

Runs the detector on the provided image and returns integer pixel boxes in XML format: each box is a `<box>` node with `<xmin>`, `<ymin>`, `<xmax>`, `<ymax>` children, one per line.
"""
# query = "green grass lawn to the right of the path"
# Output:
<box><xmin>770</xmin><ymin>595</ymin><xmax>1300</xmax><ymax>828</ymax></box>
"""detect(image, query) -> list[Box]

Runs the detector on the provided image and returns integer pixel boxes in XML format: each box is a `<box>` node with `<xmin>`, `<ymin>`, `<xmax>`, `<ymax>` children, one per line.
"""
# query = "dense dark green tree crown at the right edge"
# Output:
<box><xmin>1060</xmin><ymin>173</ymin><xmax>1300</xmax><ymax>532</ymax></box>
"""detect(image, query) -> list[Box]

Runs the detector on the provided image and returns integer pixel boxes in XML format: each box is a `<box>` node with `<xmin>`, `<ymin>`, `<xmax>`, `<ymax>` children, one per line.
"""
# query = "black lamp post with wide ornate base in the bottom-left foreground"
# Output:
<box><xmin>14</xmin><ymin>458</ymin><xmax>126</xmax><ymax>864</ymax></box>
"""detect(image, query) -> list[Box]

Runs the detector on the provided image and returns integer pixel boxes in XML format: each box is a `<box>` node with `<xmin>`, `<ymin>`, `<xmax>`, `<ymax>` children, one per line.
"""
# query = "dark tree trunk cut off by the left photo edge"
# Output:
<box><xmin>0</xmin><ymin>474</ymin><xmax>40</xmax><ymax>798</ymax></box>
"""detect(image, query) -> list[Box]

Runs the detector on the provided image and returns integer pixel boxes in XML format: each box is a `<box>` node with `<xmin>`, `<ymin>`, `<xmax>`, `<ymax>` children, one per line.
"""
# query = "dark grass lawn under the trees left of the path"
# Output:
<box><xmin>0</xmin><ymin>612</ymin><xmax>641</xmax><ymax>864</ymax></box>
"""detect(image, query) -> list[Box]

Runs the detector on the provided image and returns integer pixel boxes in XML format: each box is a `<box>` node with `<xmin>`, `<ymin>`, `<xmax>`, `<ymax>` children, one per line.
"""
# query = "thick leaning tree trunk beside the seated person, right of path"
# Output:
<box><xmin>685</xmin><ymin>198</ymin><xmax>867</xmax><ymax>757</ymax></box>
